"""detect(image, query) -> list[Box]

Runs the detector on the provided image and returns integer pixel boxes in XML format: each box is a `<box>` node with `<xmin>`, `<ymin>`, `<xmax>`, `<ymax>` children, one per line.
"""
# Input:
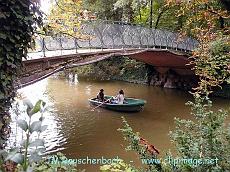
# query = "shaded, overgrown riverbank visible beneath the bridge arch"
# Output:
<box><xmin>60</xmin><ymin>57</ymin><xmax>230</xmax><ymax>98</ymax></box>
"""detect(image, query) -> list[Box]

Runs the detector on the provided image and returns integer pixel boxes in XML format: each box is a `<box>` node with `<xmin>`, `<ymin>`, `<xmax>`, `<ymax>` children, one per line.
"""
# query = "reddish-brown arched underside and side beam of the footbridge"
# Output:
<box><xmin>15</xmin><ymin>49</ymin><xmax>194</xmax><ymax>87</ymax></box>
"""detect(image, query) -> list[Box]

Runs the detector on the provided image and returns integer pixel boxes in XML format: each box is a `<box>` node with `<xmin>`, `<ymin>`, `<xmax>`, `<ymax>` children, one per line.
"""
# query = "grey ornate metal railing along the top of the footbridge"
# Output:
<box><xmin>28</xmin><ymin>21</ymin><xmax>198</xmax><ymax>56</ymax></box>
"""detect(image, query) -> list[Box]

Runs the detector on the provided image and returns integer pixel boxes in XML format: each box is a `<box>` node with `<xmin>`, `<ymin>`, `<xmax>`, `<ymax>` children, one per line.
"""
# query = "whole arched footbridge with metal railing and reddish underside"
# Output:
<box><xmin>16</xmin><ymin>21</ymin><xmax>198</xmax><ymax>87</ymax></box>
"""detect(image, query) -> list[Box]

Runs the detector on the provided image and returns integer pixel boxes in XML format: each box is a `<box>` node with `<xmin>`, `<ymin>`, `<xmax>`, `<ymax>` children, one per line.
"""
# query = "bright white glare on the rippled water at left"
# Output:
<box><xmin>7</xmin><ymin>79</ymin><xmax>66</xmax><ymax>153</ymax></box>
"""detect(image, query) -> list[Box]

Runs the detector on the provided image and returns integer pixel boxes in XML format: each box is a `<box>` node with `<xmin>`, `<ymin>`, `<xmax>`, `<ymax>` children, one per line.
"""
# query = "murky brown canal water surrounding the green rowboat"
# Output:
<box><xmin>8</xmin><ymin>77</ymin><xmax>230</xmax><ymax>171</ymax></box>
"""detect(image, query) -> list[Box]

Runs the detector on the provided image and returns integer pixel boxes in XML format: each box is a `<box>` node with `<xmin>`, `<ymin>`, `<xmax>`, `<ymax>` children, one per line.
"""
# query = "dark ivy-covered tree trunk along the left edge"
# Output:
<box><xmin>0</xmin><ymin>0</ymin><xmax>42</xmax><ymax>147</ymax></box>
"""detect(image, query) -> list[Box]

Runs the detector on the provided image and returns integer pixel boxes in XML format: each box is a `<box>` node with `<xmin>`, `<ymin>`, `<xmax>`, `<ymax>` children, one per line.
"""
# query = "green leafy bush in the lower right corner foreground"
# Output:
<box><xmin>170</xmin><ymin>94</ymin><xmax>230</xmax><ymax>171</ymax></box>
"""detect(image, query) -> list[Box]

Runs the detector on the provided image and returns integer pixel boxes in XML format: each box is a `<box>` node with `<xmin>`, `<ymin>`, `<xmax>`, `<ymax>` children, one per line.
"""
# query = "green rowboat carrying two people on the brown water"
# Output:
<box><xmin>89</xmin><ymin>96</ymin><xmax>146</xmax><ymax>112</ymax></box>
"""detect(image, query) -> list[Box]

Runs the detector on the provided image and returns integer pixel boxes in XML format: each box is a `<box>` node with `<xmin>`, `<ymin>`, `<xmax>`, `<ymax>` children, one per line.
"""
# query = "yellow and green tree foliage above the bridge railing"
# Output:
<box><xmin>51</xmin><ymin>0</ymin><xmax>189</xmax><ymax>32</ymax></box>
